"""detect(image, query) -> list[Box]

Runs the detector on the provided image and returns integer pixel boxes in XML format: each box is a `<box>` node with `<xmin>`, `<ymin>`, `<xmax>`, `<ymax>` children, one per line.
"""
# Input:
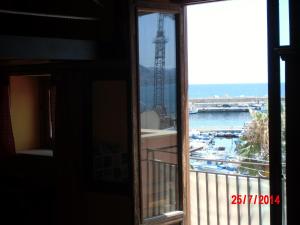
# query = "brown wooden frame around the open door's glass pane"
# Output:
<box><xmin>130</xmin><ymin>2</ymin><xmax>190</xmax><ymax>225</ymax></box>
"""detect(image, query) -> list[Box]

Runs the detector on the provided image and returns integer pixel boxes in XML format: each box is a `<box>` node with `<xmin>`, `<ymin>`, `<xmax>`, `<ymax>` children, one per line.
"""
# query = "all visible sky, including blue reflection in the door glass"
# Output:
<box><xmin>138</xmin><ymin>0</ymin><xmax>289</xmax><ymax>84</ymax></box>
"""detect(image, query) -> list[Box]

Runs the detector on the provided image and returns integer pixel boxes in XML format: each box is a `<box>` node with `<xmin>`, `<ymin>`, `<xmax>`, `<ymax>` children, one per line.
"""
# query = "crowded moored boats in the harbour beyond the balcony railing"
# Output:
<box><xmin>189</xmin><ymin>128</ymin><xmax>244</xmax><ymax>174</ymax></box>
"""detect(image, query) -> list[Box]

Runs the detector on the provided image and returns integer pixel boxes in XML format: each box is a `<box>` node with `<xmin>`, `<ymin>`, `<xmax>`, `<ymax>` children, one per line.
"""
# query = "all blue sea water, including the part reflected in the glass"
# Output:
<box><xmin>140</xmin><ymin>83</ymin><xmax>285</xmax><ymax>128</ymax></box>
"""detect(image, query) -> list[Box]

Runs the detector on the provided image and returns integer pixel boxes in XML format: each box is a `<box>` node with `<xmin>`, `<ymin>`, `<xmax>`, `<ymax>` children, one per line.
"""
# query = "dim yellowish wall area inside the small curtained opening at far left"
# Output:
<box><xmin>10</xmin><ymin>76</ymin><xmax>40</xmax><ymax>152</ymax></box>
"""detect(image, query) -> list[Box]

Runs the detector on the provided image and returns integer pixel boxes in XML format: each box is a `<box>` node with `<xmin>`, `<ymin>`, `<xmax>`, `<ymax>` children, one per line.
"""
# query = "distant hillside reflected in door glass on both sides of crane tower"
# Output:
<box><xmin>139</xmin><ymin>65</ymin><xmax>176</xmax><ymax>86</ymax></box>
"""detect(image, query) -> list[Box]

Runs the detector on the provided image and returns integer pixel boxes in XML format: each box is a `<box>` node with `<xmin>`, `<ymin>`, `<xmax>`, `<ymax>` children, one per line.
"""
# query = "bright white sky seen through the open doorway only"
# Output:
<box><xmin>187</xmin><ymin>0</ymin><xmax>268</xmax><ymax>84</ymax></box>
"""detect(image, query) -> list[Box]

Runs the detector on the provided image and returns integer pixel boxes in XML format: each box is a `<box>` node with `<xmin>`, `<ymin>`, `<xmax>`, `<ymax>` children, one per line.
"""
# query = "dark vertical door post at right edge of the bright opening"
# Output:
<box><xmin>184</xmin><ymin>0</ymin><xmax>284</xmax><ymax>225</ymax></box>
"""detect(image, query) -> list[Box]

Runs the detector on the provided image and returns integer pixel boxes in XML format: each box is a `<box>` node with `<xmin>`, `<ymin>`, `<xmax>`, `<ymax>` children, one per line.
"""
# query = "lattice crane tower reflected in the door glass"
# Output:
<box><xmin>153</xmin><ymin>13</ymin><xmax>167</xmax><ymax>116</ymax></box>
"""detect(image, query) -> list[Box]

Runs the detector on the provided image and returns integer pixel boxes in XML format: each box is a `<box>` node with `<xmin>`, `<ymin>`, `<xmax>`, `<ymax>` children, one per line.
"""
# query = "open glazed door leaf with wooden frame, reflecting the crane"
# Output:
<box><xmin>132</xmin><ymin>3</ymin><xmax>187</xmax><ymax>224</ymax></box>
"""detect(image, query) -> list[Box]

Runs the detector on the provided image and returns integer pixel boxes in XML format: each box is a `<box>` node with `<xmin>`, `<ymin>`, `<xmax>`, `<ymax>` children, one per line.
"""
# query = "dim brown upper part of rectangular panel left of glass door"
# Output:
<box><xmin>93</xmin><ymin>81</ymin><xmax>127</xmax><ymax>152</ymax></box>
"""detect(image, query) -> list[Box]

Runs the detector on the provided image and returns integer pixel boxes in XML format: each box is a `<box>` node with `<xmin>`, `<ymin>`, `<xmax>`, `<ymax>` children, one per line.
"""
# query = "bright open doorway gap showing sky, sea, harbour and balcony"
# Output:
<box><xmin>187</xmin><ymin>0</ymin><xmax>282</xmax><ymax>225</ymax></box>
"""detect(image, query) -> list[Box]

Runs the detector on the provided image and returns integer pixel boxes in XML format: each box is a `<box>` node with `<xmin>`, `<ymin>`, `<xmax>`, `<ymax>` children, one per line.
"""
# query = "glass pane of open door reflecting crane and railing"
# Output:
<box><xmin>138</xmin><ymin>12</ymin><xmax>178</xmax><ymax>218</ymax></box>
